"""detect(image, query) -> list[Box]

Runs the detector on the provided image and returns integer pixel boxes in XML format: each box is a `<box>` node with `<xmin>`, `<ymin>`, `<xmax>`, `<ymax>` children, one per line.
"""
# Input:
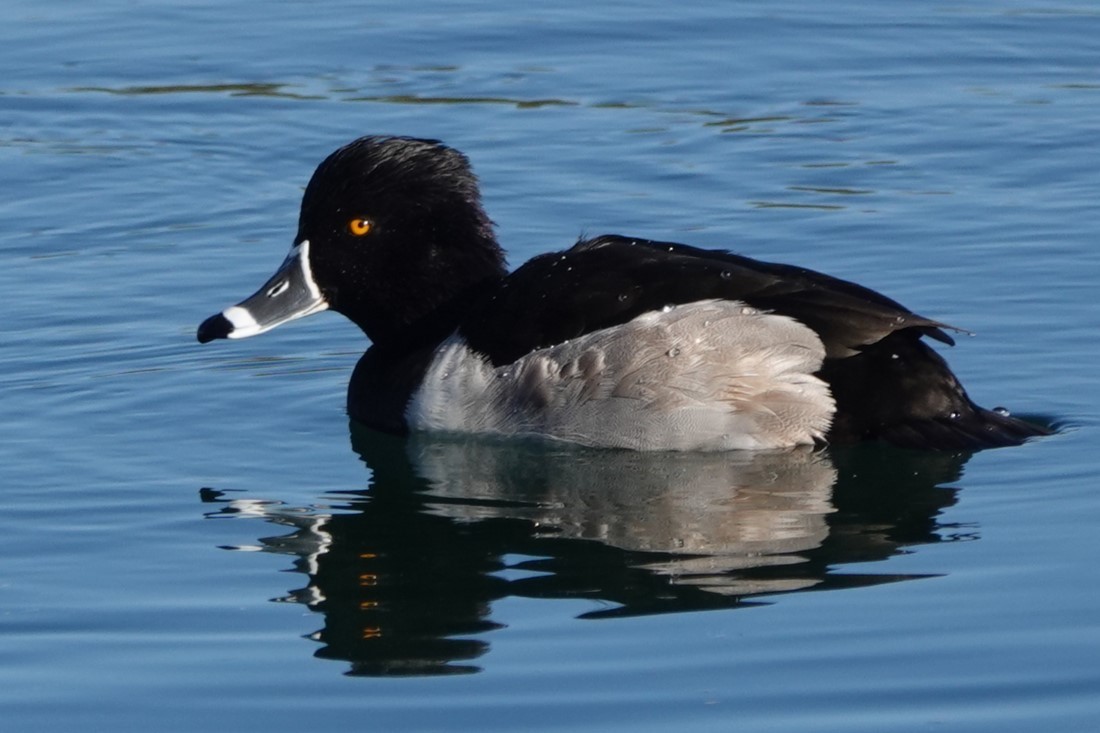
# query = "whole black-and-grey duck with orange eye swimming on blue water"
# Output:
<box><xmin>198</xmin><ymin>136</ymin><xmax>1047</xmax><ymax>450</ymax></box>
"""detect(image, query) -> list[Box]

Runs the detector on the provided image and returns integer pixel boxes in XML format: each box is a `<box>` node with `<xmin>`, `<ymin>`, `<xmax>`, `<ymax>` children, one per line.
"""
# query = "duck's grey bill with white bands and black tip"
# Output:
<box><xmin>197</xmin><ymin>240</ymin><xmax>329</xmax><ymax>343</ymax></box>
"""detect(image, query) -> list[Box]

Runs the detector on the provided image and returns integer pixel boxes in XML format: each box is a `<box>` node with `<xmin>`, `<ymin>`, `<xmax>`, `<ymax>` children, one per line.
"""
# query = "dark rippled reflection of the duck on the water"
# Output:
<box><xmin>202</xmin><ymin>423</ymin><xmax>969</xmax><ymax>676</ymax></box>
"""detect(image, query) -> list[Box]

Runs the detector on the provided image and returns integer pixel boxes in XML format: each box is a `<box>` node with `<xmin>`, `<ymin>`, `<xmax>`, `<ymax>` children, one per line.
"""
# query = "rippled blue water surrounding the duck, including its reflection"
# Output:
<box><xmin>0</xmin><ymin>0</ymin><xmax>1100</xmax><ymax>733</ymax></box>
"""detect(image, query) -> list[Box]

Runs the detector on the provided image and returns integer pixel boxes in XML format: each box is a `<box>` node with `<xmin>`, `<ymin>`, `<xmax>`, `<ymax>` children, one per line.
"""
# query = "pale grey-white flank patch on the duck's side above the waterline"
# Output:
<box><xmin>406</xmin><ymin>300</ymin><xmax>835</xmax><ymax>450</ymax></box>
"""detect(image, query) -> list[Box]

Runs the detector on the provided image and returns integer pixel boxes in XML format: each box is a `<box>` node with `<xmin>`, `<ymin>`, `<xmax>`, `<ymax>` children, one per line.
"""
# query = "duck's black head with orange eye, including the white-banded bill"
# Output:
<box><xmin>198</xmin><ymin>136</ymin><xmax>505</xmax><ymax>346</ymax></box>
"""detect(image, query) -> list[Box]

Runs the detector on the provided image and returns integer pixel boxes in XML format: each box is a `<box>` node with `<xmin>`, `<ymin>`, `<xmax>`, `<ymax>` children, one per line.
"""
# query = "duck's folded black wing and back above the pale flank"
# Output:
<box><xmin>461</xmin><ymin>236</ymin><xmax>954</xmax><ymax>365</ymax></box>
